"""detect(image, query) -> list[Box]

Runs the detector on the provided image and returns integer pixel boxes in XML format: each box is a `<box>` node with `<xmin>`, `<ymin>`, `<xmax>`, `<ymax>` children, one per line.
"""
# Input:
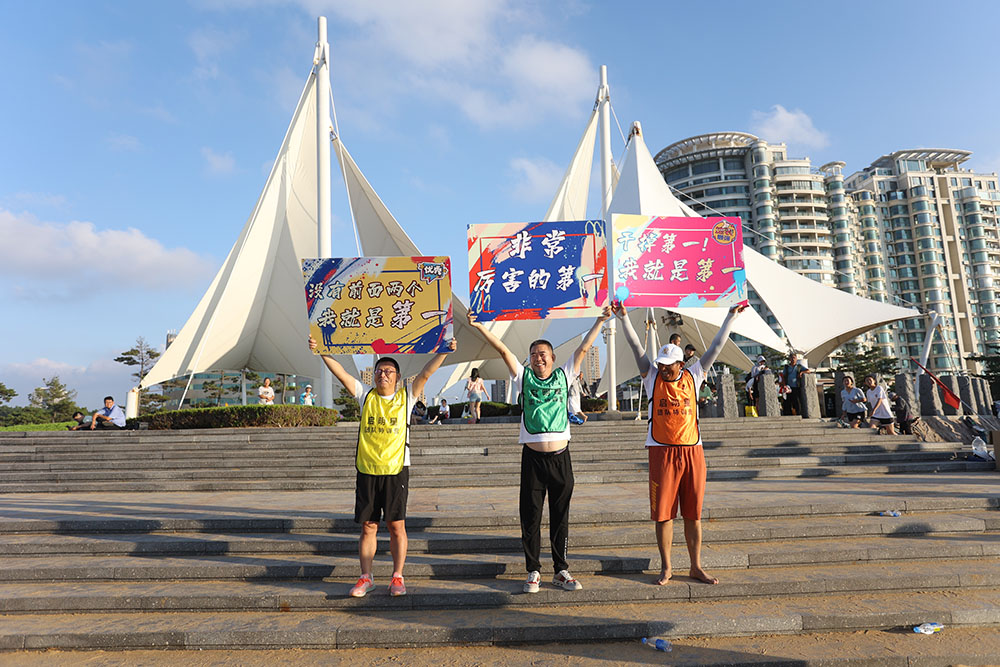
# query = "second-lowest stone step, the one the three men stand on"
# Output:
<box><xmin>0</xmin><ymin>558</ymin><xmax>1000</xmax><ymax>613</ymax></box>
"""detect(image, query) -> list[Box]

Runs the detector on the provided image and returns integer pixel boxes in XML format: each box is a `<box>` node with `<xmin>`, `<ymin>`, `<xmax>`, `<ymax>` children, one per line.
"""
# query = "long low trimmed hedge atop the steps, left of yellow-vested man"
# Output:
<box><xmin>139</xmin><ymin>405</ymin><xmax>339</xmax><ymax>430</ymax></box>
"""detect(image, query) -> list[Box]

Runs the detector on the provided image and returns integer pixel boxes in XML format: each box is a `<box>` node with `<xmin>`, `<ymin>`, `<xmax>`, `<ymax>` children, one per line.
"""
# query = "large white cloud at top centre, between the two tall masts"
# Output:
<box><xmin>200</xmin><ymin>0</ymin><xmax>597</xmax><ymax>132</ymax></box>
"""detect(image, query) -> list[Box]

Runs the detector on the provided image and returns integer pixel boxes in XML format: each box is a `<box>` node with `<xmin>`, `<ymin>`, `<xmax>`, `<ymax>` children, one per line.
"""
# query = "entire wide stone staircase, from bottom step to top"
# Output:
<box><xmin>0</xmin><ymin>418</ymin><xmax>1000</xmax><ymax>664</ymax></box>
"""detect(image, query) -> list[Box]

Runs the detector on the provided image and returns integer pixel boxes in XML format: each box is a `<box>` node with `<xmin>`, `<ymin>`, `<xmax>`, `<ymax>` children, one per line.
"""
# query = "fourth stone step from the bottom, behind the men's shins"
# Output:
<box><xmin>0</xmin><ymin>510</ymin><xmax>1000</xmax><ymax>557</ymax></box>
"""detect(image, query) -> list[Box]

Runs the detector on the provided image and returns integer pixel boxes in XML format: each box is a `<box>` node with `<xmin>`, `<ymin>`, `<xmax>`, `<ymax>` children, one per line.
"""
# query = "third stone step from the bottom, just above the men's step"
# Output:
<box><xmin>0</xmin><ymin>532</ymin><xmax>1000</xmax><ymax>583</ymax></box>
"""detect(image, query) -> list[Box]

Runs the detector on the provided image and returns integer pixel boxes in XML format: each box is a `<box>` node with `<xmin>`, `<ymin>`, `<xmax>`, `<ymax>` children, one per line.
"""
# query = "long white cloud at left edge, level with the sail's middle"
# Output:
<box><xmin>0</xmin><ymin>209</ymin><xmax>213</xmax><ymax>298</ymax></box>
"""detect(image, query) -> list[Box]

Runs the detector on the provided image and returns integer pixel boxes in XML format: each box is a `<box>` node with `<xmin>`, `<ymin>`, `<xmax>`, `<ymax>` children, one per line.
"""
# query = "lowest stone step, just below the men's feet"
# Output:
<box><xmin>0</xmin><ymin>588</ymin><xmax>1000</xmax><ymax>660</ymax></box>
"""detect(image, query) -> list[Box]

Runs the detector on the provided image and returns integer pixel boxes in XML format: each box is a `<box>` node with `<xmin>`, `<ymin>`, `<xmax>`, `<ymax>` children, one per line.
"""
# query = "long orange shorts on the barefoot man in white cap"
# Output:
<box><xmin>646</xmin><ymin>445</ymin><xmax>707</xmax><ymax>521</ymax></box>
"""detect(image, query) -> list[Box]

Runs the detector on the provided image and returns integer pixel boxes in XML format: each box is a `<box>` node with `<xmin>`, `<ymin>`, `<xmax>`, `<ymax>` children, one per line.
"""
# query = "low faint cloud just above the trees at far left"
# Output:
<box><xmin>0</xmin><ymin>354</ymin><xmax>135</xmax><ymax>410</ymax></box>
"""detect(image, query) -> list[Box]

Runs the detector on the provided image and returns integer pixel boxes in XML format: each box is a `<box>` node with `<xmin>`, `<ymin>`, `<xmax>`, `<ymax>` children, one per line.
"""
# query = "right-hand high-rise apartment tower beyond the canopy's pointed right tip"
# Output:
<box><xmin>845</xmin><ymin>149</ymin><xmax>1000</xmax><ymax>371</ymax></box>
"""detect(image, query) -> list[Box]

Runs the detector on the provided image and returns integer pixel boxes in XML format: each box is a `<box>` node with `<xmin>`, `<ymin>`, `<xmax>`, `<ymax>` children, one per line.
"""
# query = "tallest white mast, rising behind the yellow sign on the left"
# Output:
<box><xmin>316</xmin><ymin>16</ymin><xmax>333</xmax><ymax>408</ymax></box>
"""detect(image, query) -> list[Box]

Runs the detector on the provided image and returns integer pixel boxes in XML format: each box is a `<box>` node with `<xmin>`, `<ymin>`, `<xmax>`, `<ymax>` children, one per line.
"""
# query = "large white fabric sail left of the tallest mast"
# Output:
<box><xmin>140</xmin><ymin>74</ymin><xmax>354</xmax><ymax>387</ymax></box>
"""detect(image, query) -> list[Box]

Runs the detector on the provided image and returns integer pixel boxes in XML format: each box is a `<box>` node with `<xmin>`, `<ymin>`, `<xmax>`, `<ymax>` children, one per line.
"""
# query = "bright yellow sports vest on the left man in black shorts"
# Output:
<box><xmin>354</xmin><ymin>388</ymin><xmax>409</xmax><ymax>475</ymax></box>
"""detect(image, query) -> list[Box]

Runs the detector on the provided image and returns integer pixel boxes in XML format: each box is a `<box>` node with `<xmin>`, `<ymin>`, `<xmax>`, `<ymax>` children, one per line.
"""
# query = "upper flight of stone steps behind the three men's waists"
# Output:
<box><xmin>0</xmin><ymin>418</ymin><xmax>992</xmax><ymax>493</ymax></box>
